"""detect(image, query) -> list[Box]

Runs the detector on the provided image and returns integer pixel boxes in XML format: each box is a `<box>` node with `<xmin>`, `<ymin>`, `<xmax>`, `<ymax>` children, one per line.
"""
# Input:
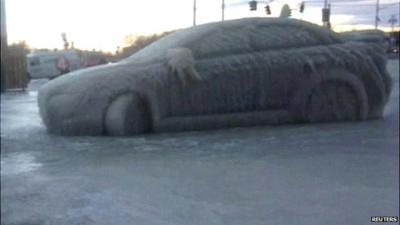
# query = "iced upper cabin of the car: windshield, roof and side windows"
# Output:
<box><xmin>126</xmin><ymin>18</ymin><xmax>342</xmax><ymax>61</ymax></box>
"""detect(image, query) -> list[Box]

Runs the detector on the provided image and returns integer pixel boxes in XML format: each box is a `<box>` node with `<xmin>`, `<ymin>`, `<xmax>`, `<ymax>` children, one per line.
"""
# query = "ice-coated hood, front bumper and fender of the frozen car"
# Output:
<box><xmin>38</xmin><ymin>60</ymin><xmax>160</xmax><ymax>135</ymax></box>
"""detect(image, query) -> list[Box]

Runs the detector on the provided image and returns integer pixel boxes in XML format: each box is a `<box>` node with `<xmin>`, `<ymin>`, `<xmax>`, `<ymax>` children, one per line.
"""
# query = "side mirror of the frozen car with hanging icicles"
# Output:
<box><xmin>166</xmin><ymin>48</ymin><xmax>203</xmax><ymax>86</ymax></box>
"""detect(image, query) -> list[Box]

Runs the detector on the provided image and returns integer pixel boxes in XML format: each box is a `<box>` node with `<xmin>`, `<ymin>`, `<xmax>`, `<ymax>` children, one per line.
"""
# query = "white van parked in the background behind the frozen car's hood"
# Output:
<box><xmin>26</xmin><ymin>50</ymin><xmax>81</xmax><ymax>79</ymax></box>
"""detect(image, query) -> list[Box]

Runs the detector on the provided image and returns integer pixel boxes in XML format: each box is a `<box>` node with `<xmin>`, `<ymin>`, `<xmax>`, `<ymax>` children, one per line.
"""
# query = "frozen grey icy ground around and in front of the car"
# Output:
<box><xmin>1</xmin><ymin>60</ymin><xmax>399</xmax><ymax>225</ymax></box>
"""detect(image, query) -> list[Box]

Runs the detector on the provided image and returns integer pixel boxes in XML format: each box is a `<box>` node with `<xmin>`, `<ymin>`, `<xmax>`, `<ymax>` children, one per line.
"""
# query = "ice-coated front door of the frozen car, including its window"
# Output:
<box><xmin>169</xmin><ymin>25</ymin><xmax>260</xmax><ymax>116</ymax></box>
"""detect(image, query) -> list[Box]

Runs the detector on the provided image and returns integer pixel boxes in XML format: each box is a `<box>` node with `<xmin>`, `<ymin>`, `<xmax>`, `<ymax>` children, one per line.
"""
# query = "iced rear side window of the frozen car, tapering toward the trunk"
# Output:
<box><xmin>249</xmin><ymin>24</ymin><xmax>323</xmax><ymax>50</ymax></box>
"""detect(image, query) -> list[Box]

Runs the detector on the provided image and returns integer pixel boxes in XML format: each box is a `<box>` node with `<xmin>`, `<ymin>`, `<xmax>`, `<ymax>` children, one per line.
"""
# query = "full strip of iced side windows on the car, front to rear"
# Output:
<box><xmin>191</xmin><ymin>20</ymin><xmax>340</xmax><ymax>59</ymax></box>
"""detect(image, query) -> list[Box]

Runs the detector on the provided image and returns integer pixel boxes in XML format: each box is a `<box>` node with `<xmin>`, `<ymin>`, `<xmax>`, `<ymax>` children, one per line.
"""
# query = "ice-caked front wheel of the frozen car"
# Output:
<box><xmin>104</xmin><ymin>93</ymin><xmax>151</xmax><ymax>136</ymax></box>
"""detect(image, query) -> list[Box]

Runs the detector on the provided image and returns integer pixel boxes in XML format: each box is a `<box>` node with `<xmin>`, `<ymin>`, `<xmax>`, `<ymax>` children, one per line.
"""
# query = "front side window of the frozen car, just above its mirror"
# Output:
<box><xmin>191</xmin><ymin>26</ymin><xmax>251</xmax><ymax>59</ymax></box>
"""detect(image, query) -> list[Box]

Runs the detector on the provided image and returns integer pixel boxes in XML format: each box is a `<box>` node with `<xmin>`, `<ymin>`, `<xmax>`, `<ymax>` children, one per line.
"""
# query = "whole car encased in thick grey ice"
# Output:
<box><xmin>38</xmin><ymin>18</ymin><xmax>391</xmax><ymax>135</ymax></box>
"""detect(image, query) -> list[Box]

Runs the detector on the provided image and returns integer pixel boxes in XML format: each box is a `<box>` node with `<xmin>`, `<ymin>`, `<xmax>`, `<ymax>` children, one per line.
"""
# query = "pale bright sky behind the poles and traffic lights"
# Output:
<box><xmin>6</xmin><ymin>0</ymin><xmax>400</xmax><ymax>52</ymax></box>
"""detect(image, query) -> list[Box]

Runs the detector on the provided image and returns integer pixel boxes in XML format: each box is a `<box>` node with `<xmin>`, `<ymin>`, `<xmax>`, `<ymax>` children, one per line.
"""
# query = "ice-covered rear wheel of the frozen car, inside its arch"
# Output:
<box><xmin>305</xmin><ymin>80</ymin><xmax>361</xmax><ymax>122</ymax></box>
